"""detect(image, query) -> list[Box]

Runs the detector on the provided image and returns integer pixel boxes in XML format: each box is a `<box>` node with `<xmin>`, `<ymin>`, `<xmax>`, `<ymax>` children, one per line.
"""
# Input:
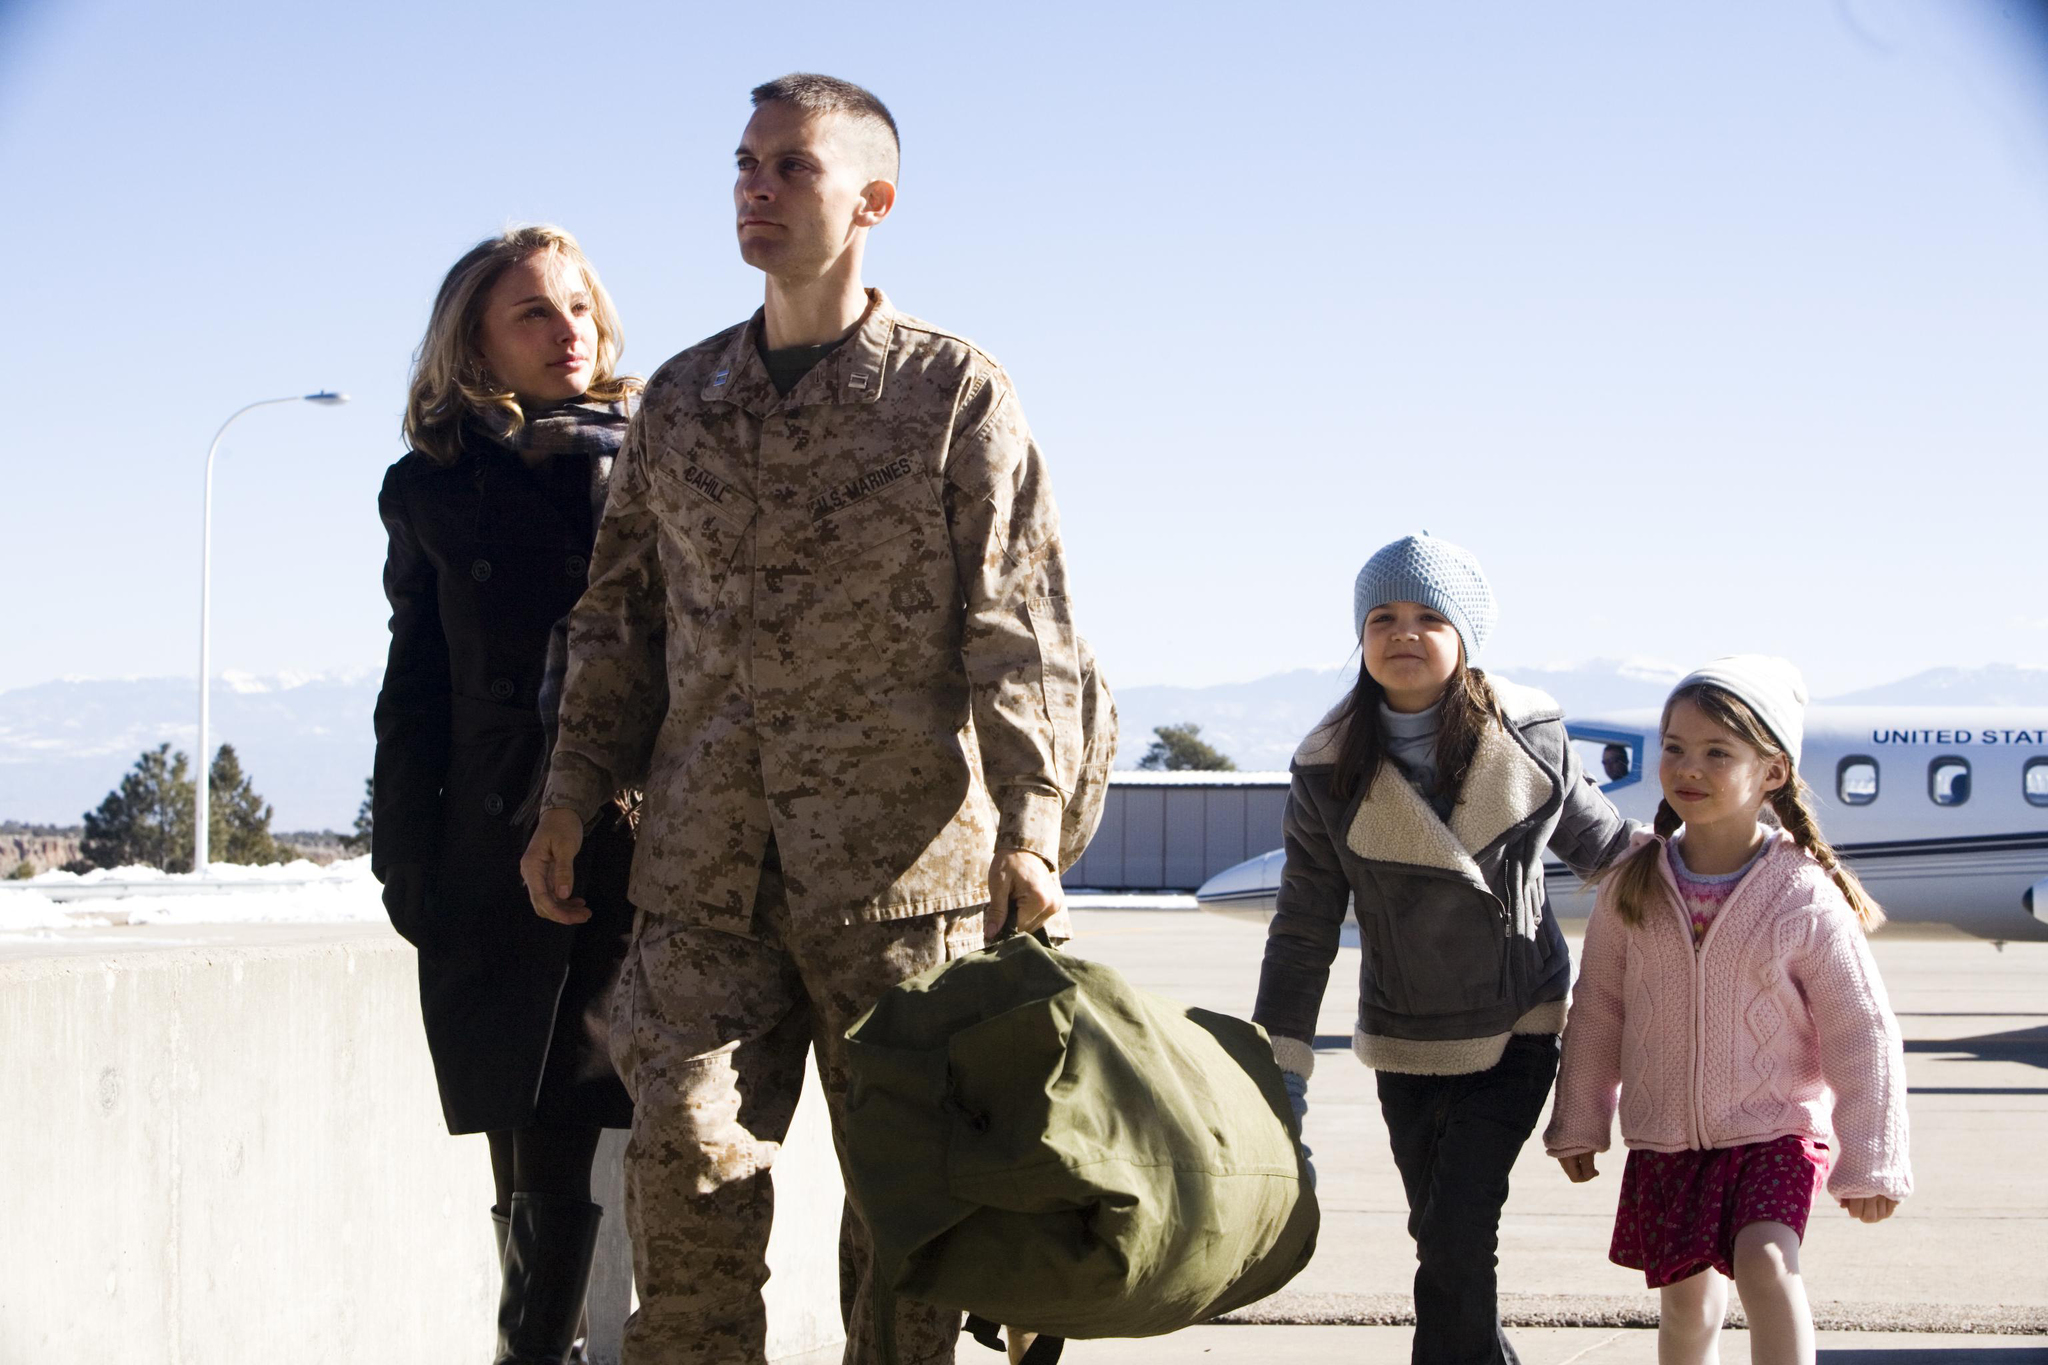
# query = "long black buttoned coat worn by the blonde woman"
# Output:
<box><xmin>371</xmin><ymin>436</ymin><xmax>633</xmax><ymax>1134</ymax></box>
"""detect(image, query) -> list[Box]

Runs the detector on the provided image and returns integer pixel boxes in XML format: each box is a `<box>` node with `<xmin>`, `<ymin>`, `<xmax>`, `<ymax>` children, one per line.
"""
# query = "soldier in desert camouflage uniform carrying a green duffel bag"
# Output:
<box><xmin>524</xmin><ymin>76</ymin><xmax>1081</xmax><ymax>1365</ymax></box>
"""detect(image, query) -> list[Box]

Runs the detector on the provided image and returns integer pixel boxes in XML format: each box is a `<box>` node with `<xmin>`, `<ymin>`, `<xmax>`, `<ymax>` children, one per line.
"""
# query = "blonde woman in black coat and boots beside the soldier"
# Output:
<box><xmin>371</xmin><ymin>227</ymin><xmax>639</xmax><ymax>1363</ymax></box>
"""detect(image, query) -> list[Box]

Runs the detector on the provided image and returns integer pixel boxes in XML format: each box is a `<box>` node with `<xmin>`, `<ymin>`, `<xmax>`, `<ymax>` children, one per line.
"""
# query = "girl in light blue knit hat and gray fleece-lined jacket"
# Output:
<box><xmin>1253</xmin><ymin>532</ymin><xmax>1630</xmax><ymax>1365</ymax></box>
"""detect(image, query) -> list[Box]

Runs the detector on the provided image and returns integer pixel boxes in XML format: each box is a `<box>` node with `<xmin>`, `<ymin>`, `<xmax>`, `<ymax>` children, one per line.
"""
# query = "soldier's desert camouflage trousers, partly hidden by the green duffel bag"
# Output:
<box><xmin>612</xmin><ymin>866</ymin><xmax>981</xmax><ymax>1365</ymax></box>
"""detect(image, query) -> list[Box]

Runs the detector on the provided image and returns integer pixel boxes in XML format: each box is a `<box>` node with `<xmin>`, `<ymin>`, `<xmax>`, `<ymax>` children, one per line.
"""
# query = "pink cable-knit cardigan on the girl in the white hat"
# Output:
<box><xmin>1544</xmin><ymin>833</ymin><xmax>1913</xmax><ymax>1199</ymax></box>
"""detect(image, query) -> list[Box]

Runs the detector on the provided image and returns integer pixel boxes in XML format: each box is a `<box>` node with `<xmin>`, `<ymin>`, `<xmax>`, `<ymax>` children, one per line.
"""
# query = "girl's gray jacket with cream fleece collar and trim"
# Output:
<box><xmin>1253</xmin><ymin>677</ymin><xmax>1634</xmax><ymax>1076</ymax></box>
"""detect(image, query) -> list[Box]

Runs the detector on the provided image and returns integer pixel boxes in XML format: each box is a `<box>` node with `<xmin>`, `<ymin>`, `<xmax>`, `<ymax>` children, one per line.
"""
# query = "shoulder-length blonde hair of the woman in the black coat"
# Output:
<box><xmin>406</xmin><ymin>223</ymin><xmax>639</xmax><ymax>465</ymax></box>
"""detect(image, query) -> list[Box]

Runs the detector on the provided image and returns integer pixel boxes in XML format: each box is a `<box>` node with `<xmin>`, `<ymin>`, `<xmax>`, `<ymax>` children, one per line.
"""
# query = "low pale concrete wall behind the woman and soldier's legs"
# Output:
<box><xmin>0</xmin><ymin>925</ymin><xmax>840</xmax><ymax>1365</ymax></box>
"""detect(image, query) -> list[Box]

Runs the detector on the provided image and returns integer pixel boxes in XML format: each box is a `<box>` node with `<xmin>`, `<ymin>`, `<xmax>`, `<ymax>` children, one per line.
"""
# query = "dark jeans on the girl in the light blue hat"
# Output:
<box><xmin>1376</xmin><ymin>1033</ymin><xmax>1556</xmax><ymax>1365</ymax></box>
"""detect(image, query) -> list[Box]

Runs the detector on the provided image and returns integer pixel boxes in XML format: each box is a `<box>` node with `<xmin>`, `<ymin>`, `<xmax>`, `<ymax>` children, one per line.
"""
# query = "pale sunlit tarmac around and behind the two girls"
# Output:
<box><xmin>1048</xmin><ymin>909</ymin><xmax>2048</xmax><ymax>1365</ymax></box>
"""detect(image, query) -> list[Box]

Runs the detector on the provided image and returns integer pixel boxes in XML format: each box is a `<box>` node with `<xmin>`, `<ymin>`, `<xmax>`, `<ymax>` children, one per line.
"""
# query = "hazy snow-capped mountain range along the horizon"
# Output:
<box><xmin>0</xmin><ymin>659</ymin><xmax>2048</xmax><ymax>831</ymax></box>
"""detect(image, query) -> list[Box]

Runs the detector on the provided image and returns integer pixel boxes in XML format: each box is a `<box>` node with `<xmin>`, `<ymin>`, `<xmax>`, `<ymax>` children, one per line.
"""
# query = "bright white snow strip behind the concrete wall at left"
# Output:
<box><xmin>0</xmin><ymin>857</ymin><xmax>385</xmax><ymax>931</ymax></box>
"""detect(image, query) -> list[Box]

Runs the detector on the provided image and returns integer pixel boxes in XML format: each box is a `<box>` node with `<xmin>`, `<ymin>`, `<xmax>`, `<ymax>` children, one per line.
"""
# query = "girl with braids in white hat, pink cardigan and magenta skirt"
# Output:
<box><xmin>1544</xmin><ymin>655</ymin><xmax>1913</xmax><ymax>1365</ymax></box>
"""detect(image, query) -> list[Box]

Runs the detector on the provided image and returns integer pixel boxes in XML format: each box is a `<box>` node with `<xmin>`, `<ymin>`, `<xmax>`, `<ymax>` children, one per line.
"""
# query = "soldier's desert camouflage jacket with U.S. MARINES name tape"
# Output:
<box><xmin>541</xmin><ymin>291</ymin><xmax>1081</xmax><ymax>931</ymax></box>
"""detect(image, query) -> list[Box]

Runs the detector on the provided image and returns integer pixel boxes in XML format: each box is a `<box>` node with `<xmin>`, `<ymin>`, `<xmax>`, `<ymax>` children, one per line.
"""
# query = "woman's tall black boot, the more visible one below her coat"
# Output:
<box><xmin>498</xmin><ymin>1195</ymin><xmax>604</xmax><ymax>1365</ymax></box>
